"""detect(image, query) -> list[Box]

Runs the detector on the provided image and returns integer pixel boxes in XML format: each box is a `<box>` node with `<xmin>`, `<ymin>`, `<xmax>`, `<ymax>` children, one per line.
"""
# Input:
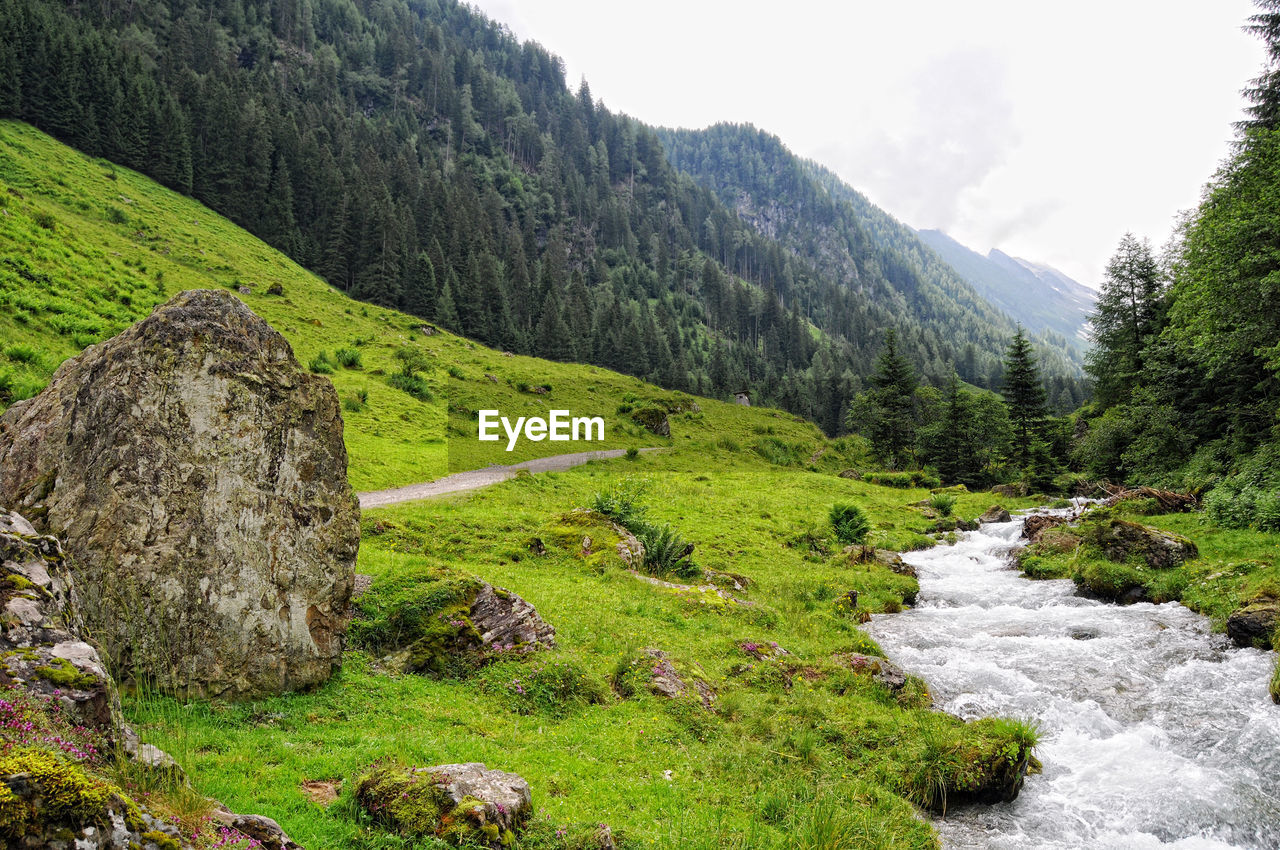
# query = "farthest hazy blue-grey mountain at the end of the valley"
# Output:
<box><xmin>919</xmin><ymin>230</ymin><xmax>1097</xmax><ymax>352</ymax></box>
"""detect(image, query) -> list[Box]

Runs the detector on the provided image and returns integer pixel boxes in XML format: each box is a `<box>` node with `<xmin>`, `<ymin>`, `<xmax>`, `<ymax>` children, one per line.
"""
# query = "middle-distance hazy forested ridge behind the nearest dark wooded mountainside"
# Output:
<box><xmin>658</xmin><ymin>124</ymin><xmax>1087</xmax><ymax>412</ymax></box>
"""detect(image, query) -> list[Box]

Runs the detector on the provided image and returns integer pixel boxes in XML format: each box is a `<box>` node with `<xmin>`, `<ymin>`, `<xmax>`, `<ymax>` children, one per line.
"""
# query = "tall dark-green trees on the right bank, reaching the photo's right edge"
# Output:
<box><xmin>1079</xmin><ymin>0</ymin><xmax>1280</xmax><ymax>504</ymax></box>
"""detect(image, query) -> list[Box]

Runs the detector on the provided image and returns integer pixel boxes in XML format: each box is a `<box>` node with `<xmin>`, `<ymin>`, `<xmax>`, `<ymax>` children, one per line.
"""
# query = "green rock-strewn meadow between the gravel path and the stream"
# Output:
<box><xmin>131</xmin><ymin>444</ymin><xmax>1044</xmax><ymax>847</ymax></box>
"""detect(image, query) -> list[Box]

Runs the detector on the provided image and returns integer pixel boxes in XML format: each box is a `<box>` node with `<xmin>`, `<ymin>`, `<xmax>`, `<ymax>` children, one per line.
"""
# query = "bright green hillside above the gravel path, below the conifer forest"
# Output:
<box><xmin>0</xmin><ymin>122</ymin><xmax>820</xmax><ymax>490</ymax></box>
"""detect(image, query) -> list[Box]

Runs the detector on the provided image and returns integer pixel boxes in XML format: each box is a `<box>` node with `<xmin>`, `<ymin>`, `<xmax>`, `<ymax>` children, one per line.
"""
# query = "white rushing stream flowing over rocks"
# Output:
<box><xmin>869</xmin><ymin>506</ymin><xmax>1280</xmax><ymax>850</ymax></box>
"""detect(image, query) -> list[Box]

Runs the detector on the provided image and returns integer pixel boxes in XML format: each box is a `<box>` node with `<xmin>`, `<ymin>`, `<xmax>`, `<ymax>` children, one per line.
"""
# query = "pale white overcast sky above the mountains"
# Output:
<box><xmin>474</xmin><ymin>0</ymin><xmax>1262</xmax><ymax>285</ymax></box>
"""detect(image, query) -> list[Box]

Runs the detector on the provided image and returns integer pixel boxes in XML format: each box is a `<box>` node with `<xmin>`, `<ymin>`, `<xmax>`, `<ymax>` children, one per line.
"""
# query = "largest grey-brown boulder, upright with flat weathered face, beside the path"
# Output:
<box><xmin>0</xmin><ymin>291</ymin><xmax>360</xmax><ymax>698</ymax></box>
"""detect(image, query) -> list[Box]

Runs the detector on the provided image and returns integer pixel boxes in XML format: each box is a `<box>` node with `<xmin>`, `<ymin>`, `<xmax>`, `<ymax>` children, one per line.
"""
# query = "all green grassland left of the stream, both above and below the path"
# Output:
<box><xmin>0</xmin><ymin>123</ymin><xmax>1049</xmax><ymax>850</ymax></box>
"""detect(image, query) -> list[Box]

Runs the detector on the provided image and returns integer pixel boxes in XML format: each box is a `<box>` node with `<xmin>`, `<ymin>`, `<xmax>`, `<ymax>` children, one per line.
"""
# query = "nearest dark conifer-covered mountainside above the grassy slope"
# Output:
<box><xmin>0</xmin><ymin>0</ymin><xmax>1085</xmax><ymax>433</ymax></box>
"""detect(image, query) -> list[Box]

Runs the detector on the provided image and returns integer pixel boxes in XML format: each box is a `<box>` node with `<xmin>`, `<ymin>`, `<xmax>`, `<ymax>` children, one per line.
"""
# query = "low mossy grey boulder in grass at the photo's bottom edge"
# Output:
<box><xmin>356</xmin><ymin>762</ymin><xmax>534</xmax><ymax>847</ymax></box>
